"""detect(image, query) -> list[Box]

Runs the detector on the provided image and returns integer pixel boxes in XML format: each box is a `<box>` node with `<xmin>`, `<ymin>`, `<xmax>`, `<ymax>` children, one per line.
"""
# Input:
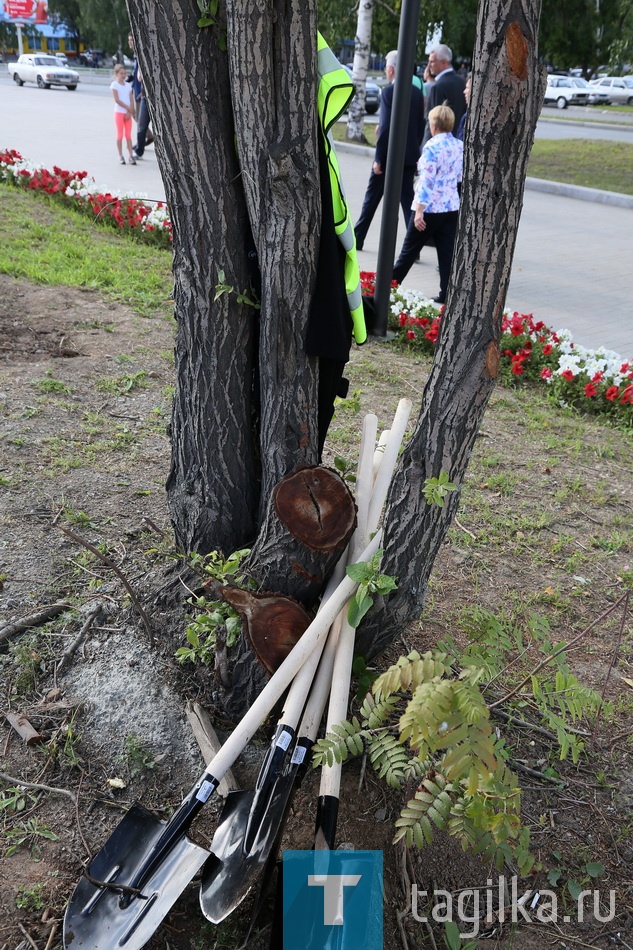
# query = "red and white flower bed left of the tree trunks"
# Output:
<box><xmin>0</xmin><ymin>149</ymin><xmax>171</xmax><ymax>247</ymax></box>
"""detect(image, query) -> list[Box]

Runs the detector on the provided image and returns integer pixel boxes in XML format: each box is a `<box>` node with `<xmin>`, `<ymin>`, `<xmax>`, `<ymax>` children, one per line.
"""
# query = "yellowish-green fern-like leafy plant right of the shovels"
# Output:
<box><xmin>314</xmin><ymin>608</ymin><xmax>600</xmax><ymax>875</ymax></box>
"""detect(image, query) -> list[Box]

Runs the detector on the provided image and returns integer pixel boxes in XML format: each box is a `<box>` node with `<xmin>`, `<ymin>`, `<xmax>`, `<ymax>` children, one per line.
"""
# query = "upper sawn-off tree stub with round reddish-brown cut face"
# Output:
<box><xmin>244</xmin><ymin>466</ymin><xmax>356</xmax><ymax>607</ymax></box>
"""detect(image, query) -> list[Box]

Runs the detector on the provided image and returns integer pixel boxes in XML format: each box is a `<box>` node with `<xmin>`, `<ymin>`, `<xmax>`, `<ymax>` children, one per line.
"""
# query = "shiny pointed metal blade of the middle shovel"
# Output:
<box><xmin>200</xmin><ymin>769</ymin><xmax>296</xmax><ymax>924</ymax></box>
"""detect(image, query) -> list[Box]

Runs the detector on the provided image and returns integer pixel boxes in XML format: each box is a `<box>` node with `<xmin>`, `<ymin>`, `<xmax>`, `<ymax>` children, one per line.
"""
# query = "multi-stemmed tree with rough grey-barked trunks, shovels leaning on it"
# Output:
<box><xmin>129</xmin><ymin>0</ymin><xmax>545</xmax><ymax>710</ymax></box>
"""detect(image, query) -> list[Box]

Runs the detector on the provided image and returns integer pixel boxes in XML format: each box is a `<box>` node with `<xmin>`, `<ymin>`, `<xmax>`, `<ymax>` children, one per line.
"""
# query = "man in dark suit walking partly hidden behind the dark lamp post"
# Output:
<box><xmin>354</xmin><ymin>50</ymin><xmax>424</xmax><ymax>251</ymax></box>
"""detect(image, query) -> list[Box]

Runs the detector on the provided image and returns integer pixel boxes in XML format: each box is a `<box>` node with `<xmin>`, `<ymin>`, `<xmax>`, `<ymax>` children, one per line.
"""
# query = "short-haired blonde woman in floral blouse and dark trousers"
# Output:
<box><xmin>393</xmin><ymin>106</ymin><xmax>464</xmax><ymax>303</ymax></box>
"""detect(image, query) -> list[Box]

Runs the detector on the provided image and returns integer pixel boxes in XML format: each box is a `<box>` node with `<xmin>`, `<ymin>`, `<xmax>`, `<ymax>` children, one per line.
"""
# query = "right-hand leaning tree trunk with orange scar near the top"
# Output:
<box><xmin>357</xmin><ymin>0</ymin><xmax>545</xmax><ymax>657</ymax></box>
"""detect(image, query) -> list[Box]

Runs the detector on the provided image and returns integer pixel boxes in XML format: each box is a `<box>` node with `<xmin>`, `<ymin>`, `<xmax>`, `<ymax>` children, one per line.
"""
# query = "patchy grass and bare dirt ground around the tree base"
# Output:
<box><xmin>0</xmin><ymin>185</ymin><xmax>633</xmax><ymax>950</ymax></box>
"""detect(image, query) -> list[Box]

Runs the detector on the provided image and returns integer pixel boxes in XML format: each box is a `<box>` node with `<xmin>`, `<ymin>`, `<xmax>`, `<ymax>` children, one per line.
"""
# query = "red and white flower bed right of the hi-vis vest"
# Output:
<box><xmin>361</xmin><ymin>271</ymin><xmax>633</xmax><ymax>426</ymax></box>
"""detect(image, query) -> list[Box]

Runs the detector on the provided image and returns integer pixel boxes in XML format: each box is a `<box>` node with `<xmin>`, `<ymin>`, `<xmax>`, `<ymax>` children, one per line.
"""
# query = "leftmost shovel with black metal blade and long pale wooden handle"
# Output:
<box><xmin>64</xmin><ymin>536</ymin><xmax>380</xmax><ymax>950</ymax></box>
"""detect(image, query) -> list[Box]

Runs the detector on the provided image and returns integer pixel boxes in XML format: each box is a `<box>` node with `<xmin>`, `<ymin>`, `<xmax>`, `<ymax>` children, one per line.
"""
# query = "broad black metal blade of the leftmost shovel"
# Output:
<box><xmin>64</xmin><ymin>805</ymin><xmax>209</xmax><ymax>950</ymax></box>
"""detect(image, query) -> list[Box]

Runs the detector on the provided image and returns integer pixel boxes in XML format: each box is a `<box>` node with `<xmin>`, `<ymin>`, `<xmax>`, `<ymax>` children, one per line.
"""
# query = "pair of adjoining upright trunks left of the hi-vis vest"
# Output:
<box><xmin>129</xmin><ymin>0</ymin><xmax>320</xmax><ymax>553</ymax></box>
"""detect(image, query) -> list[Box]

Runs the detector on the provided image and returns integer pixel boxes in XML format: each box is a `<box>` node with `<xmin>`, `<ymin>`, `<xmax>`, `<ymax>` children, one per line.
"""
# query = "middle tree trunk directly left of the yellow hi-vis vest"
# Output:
<box><xmin>226</xmin><ymin>0</ymin><xmax>321</xmax><ymax>520</ymax></box>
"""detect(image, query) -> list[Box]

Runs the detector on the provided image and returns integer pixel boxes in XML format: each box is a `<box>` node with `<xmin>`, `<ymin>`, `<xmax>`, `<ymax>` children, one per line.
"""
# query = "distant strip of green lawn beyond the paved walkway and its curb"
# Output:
<box><xmin>334</xmin><ymin>122</ymin><xmax>633</xmax><ymax>195</ymax></box>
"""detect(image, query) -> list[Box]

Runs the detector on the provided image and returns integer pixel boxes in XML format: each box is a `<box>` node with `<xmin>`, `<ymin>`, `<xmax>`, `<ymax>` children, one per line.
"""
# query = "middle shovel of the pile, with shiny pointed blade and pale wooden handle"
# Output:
<box><xmin>200</xmin><ymin>415</ymin><xmax>378</xmax><ymax>924</ymax></box>
